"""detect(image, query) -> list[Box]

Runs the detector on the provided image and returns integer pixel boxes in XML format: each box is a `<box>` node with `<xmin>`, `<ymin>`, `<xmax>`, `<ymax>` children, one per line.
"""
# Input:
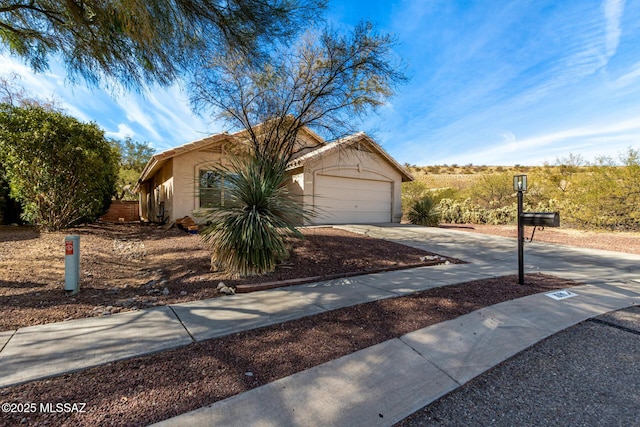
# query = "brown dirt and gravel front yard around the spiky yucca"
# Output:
<box><xmin>0</xmin><ymin>224</ymin><xmax>456</xmax><ymax>331</ymax></box>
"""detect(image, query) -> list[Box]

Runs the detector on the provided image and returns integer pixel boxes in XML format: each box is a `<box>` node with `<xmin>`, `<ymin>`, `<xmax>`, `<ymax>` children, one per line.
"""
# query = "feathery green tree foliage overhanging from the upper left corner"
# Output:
<box><xmin>0</xmin><ymin>0</ymin><xmax>324</xmax><ymax>88</ymax></box>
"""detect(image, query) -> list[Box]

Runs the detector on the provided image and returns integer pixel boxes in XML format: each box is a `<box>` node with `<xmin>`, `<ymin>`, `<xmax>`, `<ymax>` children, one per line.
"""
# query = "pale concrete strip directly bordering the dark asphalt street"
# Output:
<box><xmin>151</xmin><ymin>283</ymin><xmax>640</xmax><ymax>426</ymax></box>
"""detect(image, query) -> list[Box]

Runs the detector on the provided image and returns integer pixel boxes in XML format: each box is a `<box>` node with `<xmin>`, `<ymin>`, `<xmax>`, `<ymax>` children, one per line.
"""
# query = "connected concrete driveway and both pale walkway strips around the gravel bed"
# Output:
<box><xmin>0</xmin><ymin>226</ymin><xmax>640</xmax><ymax>425</ymax></box>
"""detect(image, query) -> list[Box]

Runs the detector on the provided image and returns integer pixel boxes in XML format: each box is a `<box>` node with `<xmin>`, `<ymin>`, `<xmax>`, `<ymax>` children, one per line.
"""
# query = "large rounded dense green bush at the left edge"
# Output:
<box><xmin>0</xmin><ymin>104</ymin><xmax>118</xmax><ymax>230</ymax></box>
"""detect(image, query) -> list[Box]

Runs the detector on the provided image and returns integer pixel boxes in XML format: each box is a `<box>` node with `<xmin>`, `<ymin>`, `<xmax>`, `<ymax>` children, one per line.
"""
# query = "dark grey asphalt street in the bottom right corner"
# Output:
<box><xmin>398</xmin><ymin>306</ymin><xmax>640</xmax><ymax>427</ymax></box>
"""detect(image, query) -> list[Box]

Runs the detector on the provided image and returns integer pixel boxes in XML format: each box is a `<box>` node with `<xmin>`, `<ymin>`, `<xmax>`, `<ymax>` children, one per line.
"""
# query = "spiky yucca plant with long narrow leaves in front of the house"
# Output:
<box><xmin>197</xmin><ymin>154</ymin><xmax>307</xmax><ymax>277</ymax></box>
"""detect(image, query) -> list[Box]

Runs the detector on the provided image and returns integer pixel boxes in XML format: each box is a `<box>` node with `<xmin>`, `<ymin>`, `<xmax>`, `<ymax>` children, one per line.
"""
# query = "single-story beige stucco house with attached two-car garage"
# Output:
<box><xmin>135</xmin><ymin>128</ymin><xmax>413</xmax><ymax>224</ymax></box>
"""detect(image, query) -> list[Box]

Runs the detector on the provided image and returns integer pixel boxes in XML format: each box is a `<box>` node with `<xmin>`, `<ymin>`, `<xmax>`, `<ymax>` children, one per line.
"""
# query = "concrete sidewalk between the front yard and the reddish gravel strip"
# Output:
<box><xmin>0</xmin><ymin>264</ymin><xmax>509</xmax><ymax>387</ymax></box>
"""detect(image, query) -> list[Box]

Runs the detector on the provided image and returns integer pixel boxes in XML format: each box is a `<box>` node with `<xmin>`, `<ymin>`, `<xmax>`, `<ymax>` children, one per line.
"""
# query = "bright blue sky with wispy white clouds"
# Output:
<box><xmin>0</xmin><ymin>0</ymin><xmax>640</xmax><ymax>166</ymax></box>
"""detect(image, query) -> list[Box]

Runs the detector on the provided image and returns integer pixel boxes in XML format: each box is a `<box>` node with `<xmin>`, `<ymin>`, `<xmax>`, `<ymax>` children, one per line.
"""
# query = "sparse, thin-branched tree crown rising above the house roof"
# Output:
<box><xmin>192</xmin><ymin>22</ymin><xmax>405</xmax><ymax>160</ymax></box>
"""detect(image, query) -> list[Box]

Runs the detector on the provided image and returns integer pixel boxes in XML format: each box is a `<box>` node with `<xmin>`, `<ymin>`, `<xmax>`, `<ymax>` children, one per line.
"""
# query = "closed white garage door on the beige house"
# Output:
<box><xmin>312</xmin><ymin>175</ymin><xmax>392</xmax><ymax>224</ymax></box>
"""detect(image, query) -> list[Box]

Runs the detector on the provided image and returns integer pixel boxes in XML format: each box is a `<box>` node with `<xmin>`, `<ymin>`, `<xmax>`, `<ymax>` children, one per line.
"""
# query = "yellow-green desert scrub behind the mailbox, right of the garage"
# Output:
<box><xmin>406</xmin><ymin>148</ymin><xmax>640</xmax><ymax>231</ymax></box>
